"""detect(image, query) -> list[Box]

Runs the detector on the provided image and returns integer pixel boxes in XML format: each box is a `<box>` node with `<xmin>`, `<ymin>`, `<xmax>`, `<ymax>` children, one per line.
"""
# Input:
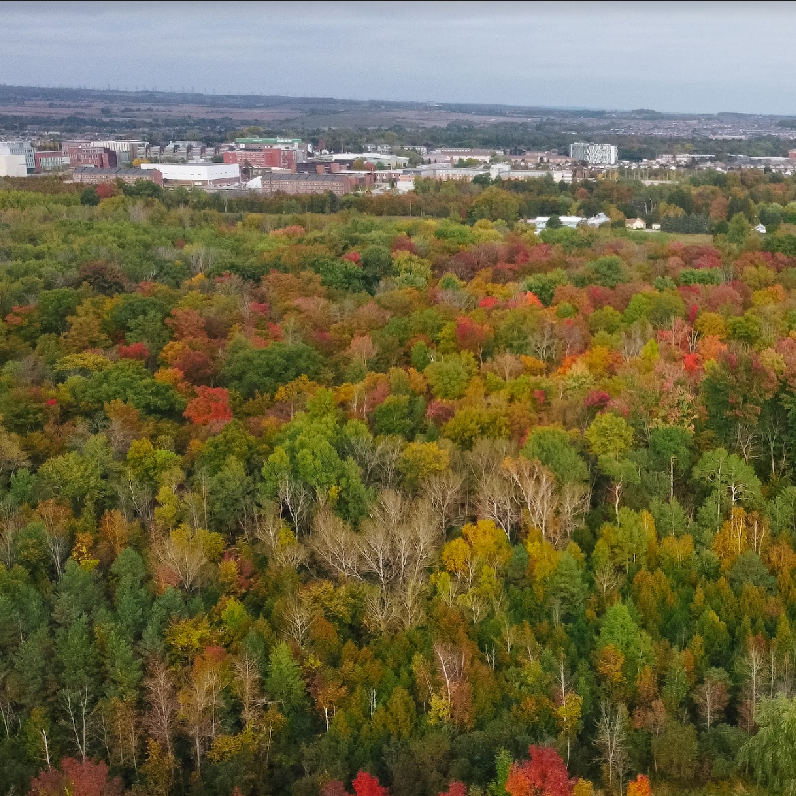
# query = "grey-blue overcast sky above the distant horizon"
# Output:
<box><xmin>0</xmin><ymin>0</ymin><xmax>796</xmax><ymax>115</ymax></box>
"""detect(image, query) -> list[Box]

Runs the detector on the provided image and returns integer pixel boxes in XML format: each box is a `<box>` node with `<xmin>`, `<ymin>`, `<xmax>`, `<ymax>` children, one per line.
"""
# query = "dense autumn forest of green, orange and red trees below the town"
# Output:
<box><xmin>0</xmin><ymin>175</ymin><xmax>796</xmax><ymax>796</ymax></box>
